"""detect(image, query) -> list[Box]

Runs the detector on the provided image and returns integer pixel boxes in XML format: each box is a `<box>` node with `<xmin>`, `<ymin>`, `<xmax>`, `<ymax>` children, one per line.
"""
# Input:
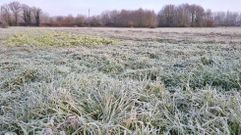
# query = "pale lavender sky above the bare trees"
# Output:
<box><xmin>0</xmin><ymin>0</ymin><xmax>241</xmax><ymax>16</ymax></box>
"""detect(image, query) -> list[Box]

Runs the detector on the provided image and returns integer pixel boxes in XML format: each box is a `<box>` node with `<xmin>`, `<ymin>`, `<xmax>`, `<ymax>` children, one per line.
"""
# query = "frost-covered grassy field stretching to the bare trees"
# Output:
<box><xmin>0</xmin><ymin>27</ymin><xmax>241</xmax><ymax>135</ymax></box>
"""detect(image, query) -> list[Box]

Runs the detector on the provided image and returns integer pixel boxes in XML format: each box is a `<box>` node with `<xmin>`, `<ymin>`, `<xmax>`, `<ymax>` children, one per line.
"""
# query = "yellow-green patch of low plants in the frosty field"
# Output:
<box><xmin>5</xmin><ymin>32</ymin><xmax>118</xmax><ymax>47</ymax></box>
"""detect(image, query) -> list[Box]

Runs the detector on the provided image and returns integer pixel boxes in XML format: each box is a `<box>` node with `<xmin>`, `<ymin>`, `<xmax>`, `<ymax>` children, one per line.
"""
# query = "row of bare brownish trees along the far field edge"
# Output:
<box><xmin>0</xmin><ymin>2</ymin><xmax>241</xmax><ymax>28</ymax></box>
